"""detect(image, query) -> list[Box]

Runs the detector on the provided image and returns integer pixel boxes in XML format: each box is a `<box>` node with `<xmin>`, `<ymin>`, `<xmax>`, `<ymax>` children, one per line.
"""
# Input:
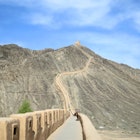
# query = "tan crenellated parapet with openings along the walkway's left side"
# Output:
<box><xmin>0</xmin><ymin>109</ymin><xmax>70</xmax><ymax>140</ymax></box>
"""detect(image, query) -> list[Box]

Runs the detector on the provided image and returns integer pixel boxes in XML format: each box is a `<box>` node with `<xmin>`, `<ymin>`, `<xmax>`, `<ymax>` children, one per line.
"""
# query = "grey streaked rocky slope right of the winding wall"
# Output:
<box><xmin>63</xmin><ymin>47</ymin><xmax>140</xmax><ymax>131</ymax></box>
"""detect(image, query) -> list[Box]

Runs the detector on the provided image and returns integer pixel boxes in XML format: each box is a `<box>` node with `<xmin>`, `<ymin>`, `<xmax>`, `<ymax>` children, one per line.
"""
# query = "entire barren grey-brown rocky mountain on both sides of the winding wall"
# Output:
<box><xmin>0</xmin><ymin>44</ymin><xmax>140</xmax><ymax>132</ymax></box>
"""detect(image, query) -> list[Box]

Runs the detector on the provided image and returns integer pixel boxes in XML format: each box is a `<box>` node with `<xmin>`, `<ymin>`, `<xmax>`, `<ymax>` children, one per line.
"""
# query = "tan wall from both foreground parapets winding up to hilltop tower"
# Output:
<box><xmin>0</xmin><ymin>42</ymin><xmax>101</xmax><ymax>140</ymax></box>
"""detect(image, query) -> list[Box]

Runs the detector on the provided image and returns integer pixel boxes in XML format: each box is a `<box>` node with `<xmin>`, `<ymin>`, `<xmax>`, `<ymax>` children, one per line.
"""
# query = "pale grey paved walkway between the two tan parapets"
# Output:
<box><xmin>47</xmin><ymin>116</ymin><xmax>83</xmax><ymax>140</ymax></box>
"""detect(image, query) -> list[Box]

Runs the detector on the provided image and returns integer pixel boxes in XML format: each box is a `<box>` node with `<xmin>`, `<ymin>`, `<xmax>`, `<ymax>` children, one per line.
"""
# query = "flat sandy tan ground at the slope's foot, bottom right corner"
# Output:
<box><xmin>98</xmin><ymin>130</ymin><xmax>140</xmax><ymax>140</ymax></box>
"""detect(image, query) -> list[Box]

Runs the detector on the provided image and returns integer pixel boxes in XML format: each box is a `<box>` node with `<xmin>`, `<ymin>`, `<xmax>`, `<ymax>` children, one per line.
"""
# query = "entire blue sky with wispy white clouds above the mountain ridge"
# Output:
<box><xmin>0</xmin><ymin>0</ymin><xmax>140</xmax><ymax>69</ymax></box>
